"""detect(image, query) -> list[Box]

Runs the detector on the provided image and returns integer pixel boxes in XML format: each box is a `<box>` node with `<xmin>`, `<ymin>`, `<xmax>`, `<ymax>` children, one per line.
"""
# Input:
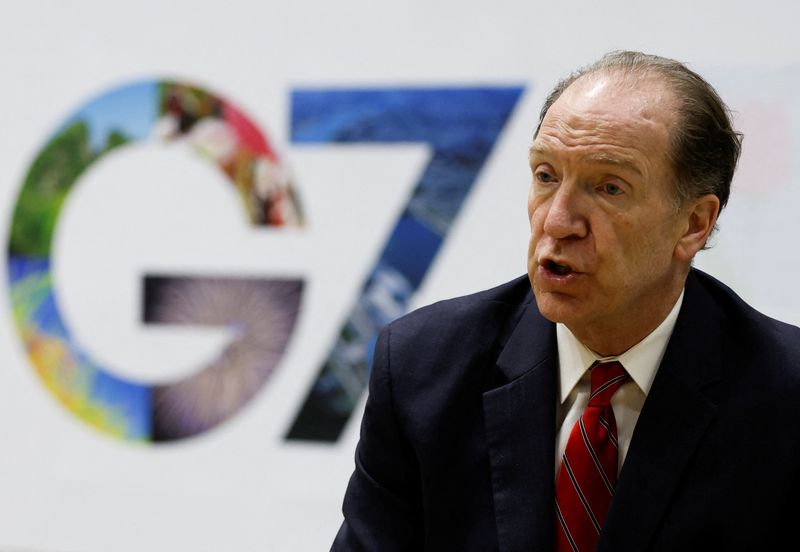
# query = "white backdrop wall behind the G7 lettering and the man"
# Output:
<box><xmin>0</xmin><ymin>0</ymin><xmax>800</xmax><ymax>552</ymax></box>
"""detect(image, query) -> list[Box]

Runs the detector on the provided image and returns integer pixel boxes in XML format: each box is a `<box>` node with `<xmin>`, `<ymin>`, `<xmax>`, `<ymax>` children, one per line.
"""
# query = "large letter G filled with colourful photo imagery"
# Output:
<box><xmin>8</xmin><ymin>81</ymin><xmax>303</xmax><ymax>442</ymax></box>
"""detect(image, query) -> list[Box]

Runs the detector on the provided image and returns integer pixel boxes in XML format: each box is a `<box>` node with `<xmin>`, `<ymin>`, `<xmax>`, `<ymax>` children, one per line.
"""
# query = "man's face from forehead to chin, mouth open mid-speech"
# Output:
<box><xmin>528</xmin><ymin>74</ymin><xmax>686</xmax><ymax>354</ymax></box>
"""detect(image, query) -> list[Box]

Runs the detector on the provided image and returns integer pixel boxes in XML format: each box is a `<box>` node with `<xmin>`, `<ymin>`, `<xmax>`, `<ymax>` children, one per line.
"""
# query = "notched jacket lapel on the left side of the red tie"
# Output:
<box><xmin>483</xmin><ymin>304</ymin><xmax>558</xmax><ymax>551</ymax></box>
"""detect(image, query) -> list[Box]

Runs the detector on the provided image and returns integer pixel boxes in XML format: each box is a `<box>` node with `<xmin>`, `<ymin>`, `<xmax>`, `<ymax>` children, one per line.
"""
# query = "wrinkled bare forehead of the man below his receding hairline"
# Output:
<box><xmin>531</xmin><ymin>74</ymin><xmax>677</xmax><ymax>168</ymax></box>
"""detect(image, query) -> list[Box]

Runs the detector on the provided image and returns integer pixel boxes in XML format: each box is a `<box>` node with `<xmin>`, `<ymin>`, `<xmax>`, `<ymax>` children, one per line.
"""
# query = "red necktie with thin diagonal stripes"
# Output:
<box><xmin>555</xmin><ymin>362</ymin><xmax>630</xmax><ymax>552</ymax></box>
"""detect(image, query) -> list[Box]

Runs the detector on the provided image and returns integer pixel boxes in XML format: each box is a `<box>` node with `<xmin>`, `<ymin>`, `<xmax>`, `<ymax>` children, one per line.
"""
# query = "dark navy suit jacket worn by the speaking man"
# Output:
<box><xmin>333</xmin><ymin>270</ymin><xmax>800</xmax><ymax>552</ymax></box>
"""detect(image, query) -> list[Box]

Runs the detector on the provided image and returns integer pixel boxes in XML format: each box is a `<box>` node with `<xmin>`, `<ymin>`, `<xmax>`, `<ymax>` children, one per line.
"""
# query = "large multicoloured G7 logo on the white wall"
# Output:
<box><xmin>8</xmin><ymin>81</ymin><xmax>522</xmax><ymax>442</ymax></box>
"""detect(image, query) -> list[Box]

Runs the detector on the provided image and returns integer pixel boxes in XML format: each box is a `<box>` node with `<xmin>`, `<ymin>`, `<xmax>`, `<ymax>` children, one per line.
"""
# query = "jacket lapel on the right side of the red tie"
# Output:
<box><xmin>598</xmin><ymin>275</ymin><xmax>723</xmax><ymax>552</ymax></box>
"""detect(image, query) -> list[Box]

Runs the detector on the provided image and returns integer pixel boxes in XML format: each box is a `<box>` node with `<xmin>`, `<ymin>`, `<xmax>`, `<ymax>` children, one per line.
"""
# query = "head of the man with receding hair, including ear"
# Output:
<box><xmin>528</xmin><ymin>53</ymin><xmax>740</xmax><ymax>354</ymax></box>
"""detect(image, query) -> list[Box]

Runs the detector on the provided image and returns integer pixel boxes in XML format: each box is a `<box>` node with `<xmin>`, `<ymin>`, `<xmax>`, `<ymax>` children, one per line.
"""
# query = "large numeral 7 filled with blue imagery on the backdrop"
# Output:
<box><xmin>286</xmin><ymin>87</ymin><xmax>523</xmax><ymax>442</ymax></box>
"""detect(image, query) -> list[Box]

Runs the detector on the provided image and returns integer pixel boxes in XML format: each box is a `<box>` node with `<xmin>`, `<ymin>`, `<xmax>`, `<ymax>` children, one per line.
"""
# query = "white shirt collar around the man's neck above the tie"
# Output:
<box><xmin>556</xmin><ymin>292</ymin><xmax>683</xmax><ymax>403</ymax></box>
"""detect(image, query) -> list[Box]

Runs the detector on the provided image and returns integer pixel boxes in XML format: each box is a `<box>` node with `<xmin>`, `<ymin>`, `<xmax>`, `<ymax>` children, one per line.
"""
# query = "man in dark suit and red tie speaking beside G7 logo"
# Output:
<box><xmin>333</xmin><ymin>52</ymin><xmax>800</xmax><ymax>552</ymax></box>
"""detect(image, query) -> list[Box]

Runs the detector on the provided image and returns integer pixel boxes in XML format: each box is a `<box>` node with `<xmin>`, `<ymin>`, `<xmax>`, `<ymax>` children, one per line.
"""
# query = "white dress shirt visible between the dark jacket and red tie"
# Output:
<box><xmin>555</xmin><ymin>292</ymin><xmax>683</xmax><ymax>473</ymax></box>
